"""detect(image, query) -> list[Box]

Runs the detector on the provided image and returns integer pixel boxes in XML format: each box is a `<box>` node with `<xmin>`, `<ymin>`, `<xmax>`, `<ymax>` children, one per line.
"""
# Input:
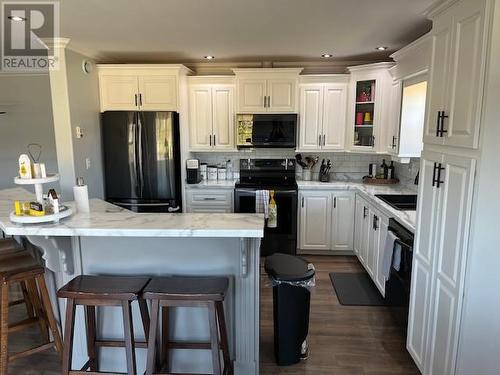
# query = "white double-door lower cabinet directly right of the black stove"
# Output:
<box><xmin>299</xmin><ymin>190</ymin><xmax>355</xmax><ymax>253</ymax></box>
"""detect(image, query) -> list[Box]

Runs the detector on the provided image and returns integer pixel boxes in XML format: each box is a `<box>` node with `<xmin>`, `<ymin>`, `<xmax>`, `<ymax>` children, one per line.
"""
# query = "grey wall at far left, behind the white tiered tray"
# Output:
<box><xmin>0</xmin><ymin>74</ymin><xmax>58</xmax><ymax>189</ymax></box>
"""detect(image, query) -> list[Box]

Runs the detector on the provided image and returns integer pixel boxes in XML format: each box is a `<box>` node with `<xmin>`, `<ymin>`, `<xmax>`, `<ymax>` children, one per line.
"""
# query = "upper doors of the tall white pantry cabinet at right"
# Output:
<box><xmin>424</xmin><ymin>0</ymin><xmax>489</xmax><ymax>148</ymax></box>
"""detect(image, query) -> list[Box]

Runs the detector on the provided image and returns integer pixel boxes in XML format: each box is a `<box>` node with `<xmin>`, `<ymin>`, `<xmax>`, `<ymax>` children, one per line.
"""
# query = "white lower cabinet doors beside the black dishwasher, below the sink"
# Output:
<box><xmin>354</xmin><ymin>195</ymin><xmax>389</xmax><ymax>296</ymax></box>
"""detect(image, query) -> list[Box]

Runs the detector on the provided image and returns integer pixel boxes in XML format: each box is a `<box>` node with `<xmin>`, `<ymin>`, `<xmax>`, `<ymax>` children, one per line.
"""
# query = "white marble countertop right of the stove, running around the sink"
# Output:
<box><xmin>297</xmin><ymin>181</ymin><xmax>417</xmax><ymax>233</ymax></box>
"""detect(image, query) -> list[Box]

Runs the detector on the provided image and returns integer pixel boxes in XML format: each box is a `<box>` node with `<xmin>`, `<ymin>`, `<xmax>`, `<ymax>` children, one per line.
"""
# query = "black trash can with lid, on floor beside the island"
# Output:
<box><xmin>265</xmin><ymin>253</ymin><xmax>315</xmax><ymax>366</ymax></box>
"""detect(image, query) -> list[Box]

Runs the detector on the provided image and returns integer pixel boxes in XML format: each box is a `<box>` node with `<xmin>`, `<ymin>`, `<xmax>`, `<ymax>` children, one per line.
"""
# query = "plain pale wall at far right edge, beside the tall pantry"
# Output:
<box><xmin>457</xmin><ymin>1</ymin><xmax>500</xmax><ymax>375</ymax></box>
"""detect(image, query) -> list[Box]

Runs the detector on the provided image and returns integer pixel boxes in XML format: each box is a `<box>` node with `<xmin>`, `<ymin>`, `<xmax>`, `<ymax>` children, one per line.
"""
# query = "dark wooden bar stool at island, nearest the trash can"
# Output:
<box><xmin>143</xmin><ymin>277</ymin><xmax>233</xmax><ymax>375</ymax></box>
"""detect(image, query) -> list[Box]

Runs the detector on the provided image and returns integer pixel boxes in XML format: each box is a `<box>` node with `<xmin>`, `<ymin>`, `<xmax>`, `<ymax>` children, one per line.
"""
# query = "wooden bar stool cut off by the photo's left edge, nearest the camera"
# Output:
<box><xmin>0</xmin><ymin>254</ymin><xmax>63</xmax><ymax>375</ymax></box>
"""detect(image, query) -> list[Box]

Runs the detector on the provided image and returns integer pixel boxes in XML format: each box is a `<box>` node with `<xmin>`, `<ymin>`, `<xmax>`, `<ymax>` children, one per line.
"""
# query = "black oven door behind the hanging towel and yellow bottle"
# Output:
<box><xmin>234</xmin><ymin>188</ymin><xmax>298</xmax><ymax>256</ymax></box>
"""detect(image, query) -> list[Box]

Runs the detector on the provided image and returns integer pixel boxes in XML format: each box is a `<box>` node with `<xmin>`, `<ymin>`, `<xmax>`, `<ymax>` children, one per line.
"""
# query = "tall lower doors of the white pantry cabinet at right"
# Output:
<box><xmin>407</xmin><ymin>151</ymin><xmax>475</xmax><ymax>375</ymax></box>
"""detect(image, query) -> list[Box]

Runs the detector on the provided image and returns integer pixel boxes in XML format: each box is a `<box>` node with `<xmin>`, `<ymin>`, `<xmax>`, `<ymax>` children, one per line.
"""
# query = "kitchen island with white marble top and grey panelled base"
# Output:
<box><xmin>0</xmin><ymin>188</ymin><xmax>264</xmax><ymax>375</ymax></box>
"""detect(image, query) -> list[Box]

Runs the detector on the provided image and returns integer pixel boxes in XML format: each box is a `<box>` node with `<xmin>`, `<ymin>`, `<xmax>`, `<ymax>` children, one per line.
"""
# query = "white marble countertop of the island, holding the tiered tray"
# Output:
<box><xmin>0</xmin><ymin>188</ymin><xmax>264</xmax><ymax>238</ymax></box>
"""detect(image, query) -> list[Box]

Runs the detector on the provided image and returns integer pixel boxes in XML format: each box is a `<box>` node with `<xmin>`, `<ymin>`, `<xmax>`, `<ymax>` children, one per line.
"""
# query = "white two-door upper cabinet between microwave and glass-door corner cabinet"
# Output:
<box><xmin>298</xmin><ymin>75</ymin><xmax>348</xmax><ymax>151</ymax></box>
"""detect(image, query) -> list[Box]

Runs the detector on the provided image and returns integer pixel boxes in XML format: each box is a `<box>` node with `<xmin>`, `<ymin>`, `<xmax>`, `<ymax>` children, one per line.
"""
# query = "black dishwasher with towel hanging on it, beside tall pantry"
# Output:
<box><xmin>385</xmin><ymin>218</ymin><xmax>413</xmax><ymax>337</ymax></box>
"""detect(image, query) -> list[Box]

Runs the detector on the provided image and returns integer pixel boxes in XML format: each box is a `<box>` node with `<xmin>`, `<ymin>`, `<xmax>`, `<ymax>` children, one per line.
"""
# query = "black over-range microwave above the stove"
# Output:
<box><xmin>236</xmin><ymin>113</ymin><xmax>297</xmax><ymax>148</ymax></box>
